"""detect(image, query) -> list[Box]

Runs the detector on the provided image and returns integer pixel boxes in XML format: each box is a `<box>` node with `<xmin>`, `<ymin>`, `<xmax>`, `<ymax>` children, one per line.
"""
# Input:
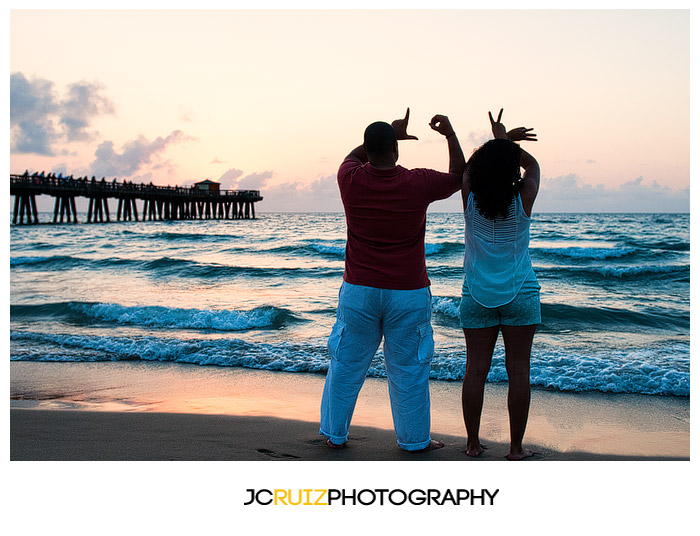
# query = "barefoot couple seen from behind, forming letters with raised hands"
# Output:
<box><xmin>320</xmin><ymin>109</ymin><xmax>541</xmax><ymax>459</ymax></box>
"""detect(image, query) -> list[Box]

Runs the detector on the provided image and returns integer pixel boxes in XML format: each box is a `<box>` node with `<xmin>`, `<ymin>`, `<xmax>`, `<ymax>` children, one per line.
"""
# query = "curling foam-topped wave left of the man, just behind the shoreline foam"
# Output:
<box><xmin>10</xmin><ymin>302</ymin><xmax>302</xmax><ymax>331</ymax></box>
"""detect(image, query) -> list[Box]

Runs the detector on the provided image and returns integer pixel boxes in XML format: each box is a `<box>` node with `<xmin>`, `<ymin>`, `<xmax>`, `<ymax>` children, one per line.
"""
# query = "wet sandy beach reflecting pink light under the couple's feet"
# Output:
<box><xmin>10</xmin><ymin>362</ymin><xmax>690</xmax><ymax>463</ymax></box>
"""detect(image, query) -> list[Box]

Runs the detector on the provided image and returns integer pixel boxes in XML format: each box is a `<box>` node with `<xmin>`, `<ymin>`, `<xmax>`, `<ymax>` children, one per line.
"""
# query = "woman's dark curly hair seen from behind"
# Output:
<box><xmin>466</xmin><ymin>139</ymin><xmax>522</xmax><ymax>220</ymax></box>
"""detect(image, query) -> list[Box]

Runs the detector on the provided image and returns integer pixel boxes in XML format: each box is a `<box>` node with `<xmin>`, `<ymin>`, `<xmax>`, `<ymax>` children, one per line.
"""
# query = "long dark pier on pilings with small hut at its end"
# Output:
<box><xmin>10</xmin><ymin>172</ymin><xmax>262</xmax><ymax>224</ymax></box>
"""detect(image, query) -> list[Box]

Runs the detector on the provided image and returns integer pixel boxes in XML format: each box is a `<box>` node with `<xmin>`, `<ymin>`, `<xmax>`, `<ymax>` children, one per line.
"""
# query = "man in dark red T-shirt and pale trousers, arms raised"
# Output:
<box><xmin>320</xmin><ymin>109</ymin><xmax>465</xmax><ymax>452</ymax></box>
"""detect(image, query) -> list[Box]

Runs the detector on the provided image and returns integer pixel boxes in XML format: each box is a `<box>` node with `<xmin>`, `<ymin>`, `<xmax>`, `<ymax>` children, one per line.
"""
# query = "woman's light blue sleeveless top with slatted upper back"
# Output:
<box><xmin>464</xmin><ymin>193</ymin><xmax>532</xmax><ymax>307</ymax></box>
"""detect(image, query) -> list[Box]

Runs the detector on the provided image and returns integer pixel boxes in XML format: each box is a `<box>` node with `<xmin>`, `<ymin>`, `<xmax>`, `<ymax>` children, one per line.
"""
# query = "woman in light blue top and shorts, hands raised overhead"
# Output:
<box><xmin>460</xmin><ymin>109</ymin><xmax>541</xmax><ymax>460</ymax></box>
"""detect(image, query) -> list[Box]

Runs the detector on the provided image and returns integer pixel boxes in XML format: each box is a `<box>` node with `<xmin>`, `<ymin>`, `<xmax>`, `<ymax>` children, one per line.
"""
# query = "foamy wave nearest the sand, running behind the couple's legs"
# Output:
<box><xmin>10</xmin><ymin>331</ymin><xmax>690</xmax><ymax>396</ymax></box>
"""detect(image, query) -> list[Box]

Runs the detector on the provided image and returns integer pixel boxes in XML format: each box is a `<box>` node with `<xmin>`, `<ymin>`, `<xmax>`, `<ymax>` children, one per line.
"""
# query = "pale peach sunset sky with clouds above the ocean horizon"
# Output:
<box><xmin>9</xmin><ymin>9</ymin><xmax>690</xmax><ymax>212</ymax></box>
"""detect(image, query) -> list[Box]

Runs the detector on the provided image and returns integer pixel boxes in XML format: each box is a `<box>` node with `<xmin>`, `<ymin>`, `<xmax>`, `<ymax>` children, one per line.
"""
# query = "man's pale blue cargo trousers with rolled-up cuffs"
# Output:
<box><xmin>320</xmin><ymin>281</ymin><xmax>434</xmax><ymax>450</ymax></box>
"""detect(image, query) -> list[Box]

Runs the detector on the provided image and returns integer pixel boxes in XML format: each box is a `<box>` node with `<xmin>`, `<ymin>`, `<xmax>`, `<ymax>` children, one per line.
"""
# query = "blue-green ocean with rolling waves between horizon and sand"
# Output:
<box><xmin>10</xmin><ymin>209</ymin><xmax>690</xmax><ymax>397</ymax></box>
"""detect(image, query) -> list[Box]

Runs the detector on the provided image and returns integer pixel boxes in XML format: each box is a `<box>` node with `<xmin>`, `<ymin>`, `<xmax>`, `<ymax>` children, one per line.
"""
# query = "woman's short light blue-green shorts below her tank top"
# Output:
<box><xmin>459</xmin><ymin>273</ymin><xmax>542</xmax><ymax>329</ymax></box>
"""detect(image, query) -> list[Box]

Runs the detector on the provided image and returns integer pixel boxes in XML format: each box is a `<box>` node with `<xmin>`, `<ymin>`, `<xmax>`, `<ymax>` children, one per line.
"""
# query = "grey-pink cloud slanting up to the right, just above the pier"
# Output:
<box><xmin>90</xmin><ymin>130</ymin><xmax>190</xmax><ymax>177</ymax></box>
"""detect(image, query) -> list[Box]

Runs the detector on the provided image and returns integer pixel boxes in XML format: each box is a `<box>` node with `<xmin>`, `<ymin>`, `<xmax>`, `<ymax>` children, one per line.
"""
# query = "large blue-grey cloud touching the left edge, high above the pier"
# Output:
<box><xmin>10</xmin><ymin>72</ymin><xmax>114</xmax><ymax>156</ymax></box>
